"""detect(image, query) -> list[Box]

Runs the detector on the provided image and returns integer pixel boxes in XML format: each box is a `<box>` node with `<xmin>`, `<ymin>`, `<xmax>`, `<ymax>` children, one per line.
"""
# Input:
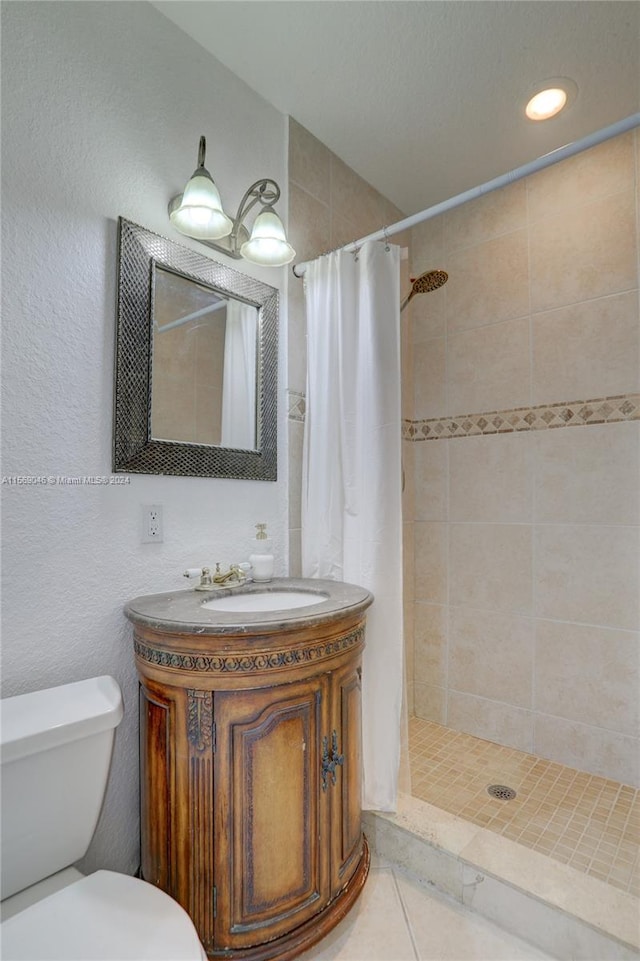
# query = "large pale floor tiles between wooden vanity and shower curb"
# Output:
<box><xmin>300</xmin><ymin>856</ymin><xmax>550</xmax><ymax>961</ymax></box>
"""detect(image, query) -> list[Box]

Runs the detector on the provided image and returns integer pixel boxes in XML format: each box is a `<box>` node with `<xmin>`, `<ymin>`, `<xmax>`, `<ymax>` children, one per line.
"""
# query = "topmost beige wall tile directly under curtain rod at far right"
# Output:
<box><xmin>524</xmin><ymin>132</ymin><xmax>634</xmax><ymax>221</ymax></box>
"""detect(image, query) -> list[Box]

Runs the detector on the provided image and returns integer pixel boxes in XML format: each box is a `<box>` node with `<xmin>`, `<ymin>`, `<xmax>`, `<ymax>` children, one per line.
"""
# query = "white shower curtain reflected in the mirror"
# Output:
<box><xmin>220</xmin><ymin>300</ymin><xmax>258</xmax><ymax>450</ymax></box>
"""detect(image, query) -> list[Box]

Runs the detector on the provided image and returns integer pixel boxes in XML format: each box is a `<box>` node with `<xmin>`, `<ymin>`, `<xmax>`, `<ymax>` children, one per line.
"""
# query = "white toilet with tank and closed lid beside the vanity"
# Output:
<box><xmin>0</xmin><ymin>676</ymin><xmax>207</xmax><ymax>961</ymax></box>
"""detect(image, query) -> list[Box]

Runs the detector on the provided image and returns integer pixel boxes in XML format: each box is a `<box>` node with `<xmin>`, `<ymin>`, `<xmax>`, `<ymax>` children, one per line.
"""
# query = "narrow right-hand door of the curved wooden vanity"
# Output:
<box><xmin>328</xmin><ymin>659</ymin><xmax>363</xmax><ymax>895</ymax></box>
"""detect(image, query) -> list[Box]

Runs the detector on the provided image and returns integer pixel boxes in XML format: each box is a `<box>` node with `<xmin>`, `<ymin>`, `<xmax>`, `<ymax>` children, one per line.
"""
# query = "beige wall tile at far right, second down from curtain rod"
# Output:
<box><xmin>529</xmin><ymin>190</ymin><xmax>638</xmax><ymax>311</ymax></box>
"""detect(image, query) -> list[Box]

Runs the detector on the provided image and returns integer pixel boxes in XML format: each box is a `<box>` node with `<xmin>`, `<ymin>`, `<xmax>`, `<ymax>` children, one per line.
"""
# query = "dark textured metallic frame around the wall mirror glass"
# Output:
<box><xmin>113</xmin><ymin>217</ymin><xmax>278</xmax><ymax>481</ymax></box>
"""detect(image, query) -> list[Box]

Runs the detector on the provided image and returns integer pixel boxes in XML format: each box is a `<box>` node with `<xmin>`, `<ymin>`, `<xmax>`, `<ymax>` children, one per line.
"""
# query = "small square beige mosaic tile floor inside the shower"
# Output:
<box><xmin>409</xmin><ymin>717</ymin><xmax>640</xmax><ymax>896</ymax></box>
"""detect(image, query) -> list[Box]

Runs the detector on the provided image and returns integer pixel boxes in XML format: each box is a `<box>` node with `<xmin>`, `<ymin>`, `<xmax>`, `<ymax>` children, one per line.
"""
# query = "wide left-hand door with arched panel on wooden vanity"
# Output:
<box><xmin>214</xmin><ymin>677</ymin><xmax>329</xmax><ymax>950</ymax></box>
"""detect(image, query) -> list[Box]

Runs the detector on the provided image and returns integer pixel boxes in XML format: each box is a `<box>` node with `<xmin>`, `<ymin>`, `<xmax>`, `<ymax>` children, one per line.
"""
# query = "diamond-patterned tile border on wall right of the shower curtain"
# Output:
<box><xmin>402</xmin><ymin>394</ymin><xmax>640</xmax><ymax>441</ymax></box>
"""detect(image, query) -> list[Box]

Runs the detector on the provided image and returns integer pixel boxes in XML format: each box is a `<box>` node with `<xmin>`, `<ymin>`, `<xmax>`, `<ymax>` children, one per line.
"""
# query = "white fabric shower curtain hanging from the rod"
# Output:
<box><xmin>302</xmin><ymin>242</ymin><xmax>403</xmax><ymax>811</ymax></box>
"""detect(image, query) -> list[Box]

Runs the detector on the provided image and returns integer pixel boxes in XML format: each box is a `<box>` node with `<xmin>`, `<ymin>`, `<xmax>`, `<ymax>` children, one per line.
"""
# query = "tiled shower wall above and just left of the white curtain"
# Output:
<box><xmin>287</xmin><ymin>118</ymin><xmax>407</xmax><ymax>577</ymax></box>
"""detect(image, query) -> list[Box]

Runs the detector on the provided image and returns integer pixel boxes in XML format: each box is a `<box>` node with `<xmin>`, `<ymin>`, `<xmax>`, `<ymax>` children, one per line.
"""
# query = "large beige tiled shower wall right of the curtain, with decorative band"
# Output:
<box><xmin>403</xmin><ymin>130</ymin><xmax>640</xmax><ymax>784</ymax></box>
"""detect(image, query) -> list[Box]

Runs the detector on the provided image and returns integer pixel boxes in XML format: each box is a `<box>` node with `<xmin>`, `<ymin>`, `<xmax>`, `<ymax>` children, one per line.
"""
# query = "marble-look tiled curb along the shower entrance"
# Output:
<box><xmin>363</xmin><ymin>795</ymin><xmax>640</xmax><ymax>961</ymax></box>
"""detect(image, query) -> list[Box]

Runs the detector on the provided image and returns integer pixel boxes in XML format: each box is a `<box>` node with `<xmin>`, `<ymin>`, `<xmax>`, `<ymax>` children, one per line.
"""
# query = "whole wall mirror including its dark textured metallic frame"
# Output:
<box><xmin>113</xmin><ymin>217</ymin><xmax>278</xmax><ymax>480</ymax></box>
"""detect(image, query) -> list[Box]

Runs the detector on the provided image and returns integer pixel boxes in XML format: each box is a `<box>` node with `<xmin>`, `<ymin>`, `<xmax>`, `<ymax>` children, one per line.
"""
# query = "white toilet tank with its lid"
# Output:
<box><xmin>0</xmin><ymin>675</ymin><xmax>123</xmax><ymax>900</ymax></box>
